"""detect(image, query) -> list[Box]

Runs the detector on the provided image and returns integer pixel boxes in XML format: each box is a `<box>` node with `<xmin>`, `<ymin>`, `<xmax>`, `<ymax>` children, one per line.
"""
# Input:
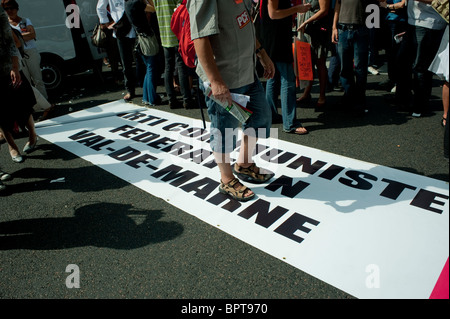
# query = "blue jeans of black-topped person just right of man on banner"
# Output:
<box><xmin>266</xmin><ymin>62</ymin><xmax>302</xmax><ymax>132</ymax></box>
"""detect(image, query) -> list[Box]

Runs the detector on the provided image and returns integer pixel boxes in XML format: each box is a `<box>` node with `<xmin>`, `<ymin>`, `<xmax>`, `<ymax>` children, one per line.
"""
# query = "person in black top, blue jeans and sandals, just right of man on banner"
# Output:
<box><xmin>257</xmin><ymin>0</ymin><xmax>311</xmax><ymax>135</ymax></box>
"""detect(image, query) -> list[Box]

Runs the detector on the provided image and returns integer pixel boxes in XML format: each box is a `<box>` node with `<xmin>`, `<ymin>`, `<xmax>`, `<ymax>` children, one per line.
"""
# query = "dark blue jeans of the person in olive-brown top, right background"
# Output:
<box><xmin>338</xmin><ymin>26</ymin><xmax>369</xmax><ymax>109</ymax></box>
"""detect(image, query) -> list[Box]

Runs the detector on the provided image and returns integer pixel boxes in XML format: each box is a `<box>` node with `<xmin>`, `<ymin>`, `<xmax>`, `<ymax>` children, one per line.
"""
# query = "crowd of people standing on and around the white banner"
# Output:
<box><xmin>0</xmin><ymin>0</ymin><xmax>449</xmax><ymax>201</ymax></box>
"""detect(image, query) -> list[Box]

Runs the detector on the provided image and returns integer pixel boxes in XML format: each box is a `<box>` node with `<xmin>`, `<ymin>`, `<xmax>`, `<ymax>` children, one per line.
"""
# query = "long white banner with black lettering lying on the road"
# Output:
<box><xmin>37</xmin><ymin>101</ymin><xmax>449</xmax><ymax>298</ymax></box>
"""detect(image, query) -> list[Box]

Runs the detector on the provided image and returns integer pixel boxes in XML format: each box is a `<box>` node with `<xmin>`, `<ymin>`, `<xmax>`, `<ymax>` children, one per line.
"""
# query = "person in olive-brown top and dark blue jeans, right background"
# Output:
<box><xmin>332</xmin><ymin>0</ymin><xmax>371</xmax><ymax>113</ymax></box>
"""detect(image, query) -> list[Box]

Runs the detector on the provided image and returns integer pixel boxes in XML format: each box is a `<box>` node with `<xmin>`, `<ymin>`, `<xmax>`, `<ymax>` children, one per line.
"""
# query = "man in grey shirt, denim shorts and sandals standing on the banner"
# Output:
<box><xmin>187</xmin><ymin>0</ymin><xmax>275</xmax><ymax>201</ymax></box>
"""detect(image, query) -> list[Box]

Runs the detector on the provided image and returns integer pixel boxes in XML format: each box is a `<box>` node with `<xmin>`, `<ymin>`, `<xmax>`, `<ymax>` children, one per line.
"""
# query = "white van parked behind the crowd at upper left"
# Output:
<box><xmin>17</xmin><ymin>0</ymin><xmax>106</xmax><ymax>93</ymax></box>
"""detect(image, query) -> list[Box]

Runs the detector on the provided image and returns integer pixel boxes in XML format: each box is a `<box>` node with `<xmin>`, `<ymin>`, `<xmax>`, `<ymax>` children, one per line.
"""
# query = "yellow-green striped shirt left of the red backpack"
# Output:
<box><xmin>153</xmin><ymin>0</ymin><xmax>180</xmax><ymax>48</ymax></box>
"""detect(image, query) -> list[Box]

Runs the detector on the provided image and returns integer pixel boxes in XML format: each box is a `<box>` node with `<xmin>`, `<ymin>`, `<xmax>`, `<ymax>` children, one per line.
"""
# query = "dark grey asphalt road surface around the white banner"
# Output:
<box><xmin>0</xmin><ymin>58</ymin><xmax>449</xmax><ymax>311</ymax></box>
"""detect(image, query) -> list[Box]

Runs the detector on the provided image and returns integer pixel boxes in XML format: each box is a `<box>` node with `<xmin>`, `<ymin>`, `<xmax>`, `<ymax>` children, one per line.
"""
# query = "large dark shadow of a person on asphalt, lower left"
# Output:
<box><xmin>0</xmin><ymin>203</ymin><xmax>184</xmax><ymax>250</ymax></box>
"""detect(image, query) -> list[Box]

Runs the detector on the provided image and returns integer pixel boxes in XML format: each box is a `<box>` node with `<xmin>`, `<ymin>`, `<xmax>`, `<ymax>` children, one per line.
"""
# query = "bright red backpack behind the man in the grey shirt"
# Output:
<box><xmin>170</xmin><ymin>0</ymin><xmax>195</xmax><ymax>68</ymax></box>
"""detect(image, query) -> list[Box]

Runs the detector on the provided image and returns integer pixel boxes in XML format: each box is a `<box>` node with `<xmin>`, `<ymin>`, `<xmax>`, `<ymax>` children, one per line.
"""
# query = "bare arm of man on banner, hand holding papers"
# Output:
<box><xmin>194</xmin><ymin>37</ymin><xmax>233</xmax><ymax>105</ymax></box>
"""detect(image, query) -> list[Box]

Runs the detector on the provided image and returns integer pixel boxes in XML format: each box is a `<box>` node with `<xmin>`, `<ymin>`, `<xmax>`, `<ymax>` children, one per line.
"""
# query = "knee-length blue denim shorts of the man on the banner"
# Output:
<box><xmin>206</xmin><ymin>78</ymin><xmax>272</xmax><ymax>153</ymax></box>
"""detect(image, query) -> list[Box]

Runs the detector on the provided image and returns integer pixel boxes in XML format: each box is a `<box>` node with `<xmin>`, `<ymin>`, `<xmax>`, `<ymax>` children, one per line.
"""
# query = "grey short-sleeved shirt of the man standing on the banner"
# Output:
<box><xmin>187</xmin><ymin>0</ymin><xmax>256</xmax><ymax>89</ymax></box>
